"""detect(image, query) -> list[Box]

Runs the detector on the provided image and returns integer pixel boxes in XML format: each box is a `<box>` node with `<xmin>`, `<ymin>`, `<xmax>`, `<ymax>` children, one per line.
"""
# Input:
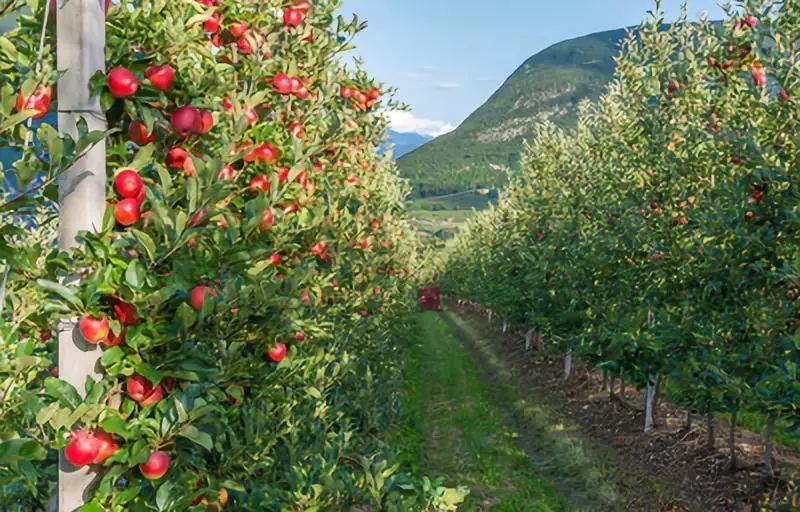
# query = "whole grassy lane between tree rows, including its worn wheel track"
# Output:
<box><xmin>392</xmin><ymin>312</ymin><xmax>658</xmax><ymax>512</ymax></box>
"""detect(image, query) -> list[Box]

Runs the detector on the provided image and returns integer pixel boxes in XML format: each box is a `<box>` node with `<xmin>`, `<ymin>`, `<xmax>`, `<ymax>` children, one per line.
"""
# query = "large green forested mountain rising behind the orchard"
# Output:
<box><xmin>398</xmin><ymin>29</ymin><xmax>626</xmax><ymax>205</ymax></box>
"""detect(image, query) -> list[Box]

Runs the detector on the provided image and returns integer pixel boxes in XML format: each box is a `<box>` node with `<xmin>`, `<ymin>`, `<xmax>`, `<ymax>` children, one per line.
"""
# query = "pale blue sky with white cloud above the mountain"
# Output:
<box><xmin>344</xmin><ymin>0</ymin><xmax>723</xmax><ymax>135</ymax></box>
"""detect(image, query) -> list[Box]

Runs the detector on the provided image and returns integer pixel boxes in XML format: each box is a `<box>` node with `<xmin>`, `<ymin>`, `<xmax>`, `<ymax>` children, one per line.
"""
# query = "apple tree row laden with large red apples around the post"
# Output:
<box><xmin>0</xmin><ymin>0</ymin><xmax>468</xmax><ymax>512</ymax></box>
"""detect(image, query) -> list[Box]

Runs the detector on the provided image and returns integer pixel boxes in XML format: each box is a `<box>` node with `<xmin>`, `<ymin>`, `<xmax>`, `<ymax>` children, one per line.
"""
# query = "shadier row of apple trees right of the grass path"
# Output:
<box><xmin>442</xmin><ymin>1</ymin><xmax>800</xmax><ymax>474</ymax></box>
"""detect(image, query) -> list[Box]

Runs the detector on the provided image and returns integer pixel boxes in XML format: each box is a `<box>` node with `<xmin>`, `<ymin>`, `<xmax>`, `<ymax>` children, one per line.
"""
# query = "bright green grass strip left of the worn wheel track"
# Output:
<box><xmin>390</xmin><ymin>313</ymin><xmax>569</xmax><ymax>512</ymax></box>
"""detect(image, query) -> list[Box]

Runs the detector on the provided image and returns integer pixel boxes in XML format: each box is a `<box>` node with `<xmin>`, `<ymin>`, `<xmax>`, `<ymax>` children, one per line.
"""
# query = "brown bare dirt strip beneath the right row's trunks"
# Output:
<box><xmin>446</xmin><ymin>300</ymin><xmax>800</xmax><ymax>512</ymax></box>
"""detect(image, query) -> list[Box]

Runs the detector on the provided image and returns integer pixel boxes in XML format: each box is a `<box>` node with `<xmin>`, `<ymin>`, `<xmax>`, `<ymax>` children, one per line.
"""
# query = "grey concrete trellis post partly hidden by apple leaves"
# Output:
<box><xmin>55</xmin><ymin>0</ymin><xmax>107</xmax><ymax>506</ymax></box>
